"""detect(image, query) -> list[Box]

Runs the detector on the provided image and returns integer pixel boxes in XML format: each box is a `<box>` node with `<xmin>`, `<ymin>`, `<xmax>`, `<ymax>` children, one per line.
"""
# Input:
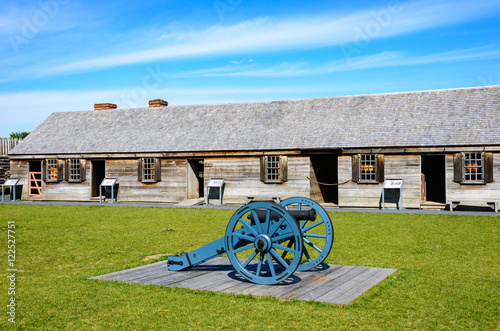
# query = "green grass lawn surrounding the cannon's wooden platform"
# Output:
<box><xmin>0</xmin><ymin>205</ymin><xmax>500</xmax><ymax>330</ymax></box>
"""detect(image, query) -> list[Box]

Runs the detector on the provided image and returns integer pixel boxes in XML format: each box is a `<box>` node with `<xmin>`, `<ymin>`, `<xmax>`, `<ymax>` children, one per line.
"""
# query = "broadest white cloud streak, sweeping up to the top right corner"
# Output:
<box><xmin>22</xmin><ymin>0</ymin><xmax>500</xmax><ymax>75</ymax></box>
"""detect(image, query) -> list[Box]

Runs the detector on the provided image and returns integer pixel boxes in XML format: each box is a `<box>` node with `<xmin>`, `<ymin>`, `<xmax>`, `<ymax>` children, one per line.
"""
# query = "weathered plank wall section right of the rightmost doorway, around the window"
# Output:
<box><xmin>446</xmin><ymin>153</ymin><xmax>500</xmax><ymax>201</ymax></box>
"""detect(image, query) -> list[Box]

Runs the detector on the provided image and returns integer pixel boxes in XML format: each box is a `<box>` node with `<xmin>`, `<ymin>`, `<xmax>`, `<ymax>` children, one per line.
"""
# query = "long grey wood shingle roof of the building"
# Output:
<box><xmin>10</xmin><ymin>86</ymin><xmax>500</xmax><ymax>156</ymax></box>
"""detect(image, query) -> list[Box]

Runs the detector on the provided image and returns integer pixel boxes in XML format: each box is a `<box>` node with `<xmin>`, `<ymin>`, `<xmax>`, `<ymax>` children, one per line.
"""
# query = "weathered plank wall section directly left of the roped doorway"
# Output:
<box><xmin>205</xmin><ymin>156</ymin><xmax>310</xmax><ymax>203</ymax></box>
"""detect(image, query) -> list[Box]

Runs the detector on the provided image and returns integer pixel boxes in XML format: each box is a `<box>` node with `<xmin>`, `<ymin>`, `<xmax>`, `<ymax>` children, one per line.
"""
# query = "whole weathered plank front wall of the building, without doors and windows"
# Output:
<box><xmin>10</xmin><ymin>153</ymin><xmax>500</xmax><ymax>208</ymax></box>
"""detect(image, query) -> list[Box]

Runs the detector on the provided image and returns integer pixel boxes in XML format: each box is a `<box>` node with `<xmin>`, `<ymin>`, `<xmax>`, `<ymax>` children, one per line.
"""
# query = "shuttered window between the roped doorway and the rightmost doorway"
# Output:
<box><xmin>352</xmin><ymin>154</ymin><xmax>384</xmax><ymax>183</ymax></box>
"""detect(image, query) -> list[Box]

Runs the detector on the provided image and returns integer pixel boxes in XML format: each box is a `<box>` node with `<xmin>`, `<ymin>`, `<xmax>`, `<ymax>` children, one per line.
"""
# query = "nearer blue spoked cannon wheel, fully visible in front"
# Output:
<box><xmin>225</xmin><ymin>202</ymin><xmax>303</xmax><ymax>285</ymax></box>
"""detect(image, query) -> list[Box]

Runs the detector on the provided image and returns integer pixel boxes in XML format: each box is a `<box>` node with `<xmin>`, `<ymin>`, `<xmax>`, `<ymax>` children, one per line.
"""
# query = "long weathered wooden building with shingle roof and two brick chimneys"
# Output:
<box><xmin>9</xmin><ymin>86</ymin><xmax>500</xmax><ymax>208</ymax></box>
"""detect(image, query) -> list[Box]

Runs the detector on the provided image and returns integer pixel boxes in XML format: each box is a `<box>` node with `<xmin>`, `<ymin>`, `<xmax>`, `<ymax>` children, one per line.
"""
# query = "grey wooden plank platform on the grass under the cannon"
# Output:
<box><xmin>91</xmin><ymin>257</ymin><xmax>397</xmax><ymax>305</ymax></box>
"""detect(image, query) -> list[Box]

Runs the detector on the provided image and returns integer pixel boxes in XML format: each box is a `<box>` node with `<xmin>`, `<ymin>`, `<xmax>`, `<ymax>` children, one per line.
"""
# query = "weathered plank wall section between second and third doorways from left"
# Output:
<box><xmin>106</xmin><ymin>159</ymin><xmax>188</xmax><ymax>202</ymax></box>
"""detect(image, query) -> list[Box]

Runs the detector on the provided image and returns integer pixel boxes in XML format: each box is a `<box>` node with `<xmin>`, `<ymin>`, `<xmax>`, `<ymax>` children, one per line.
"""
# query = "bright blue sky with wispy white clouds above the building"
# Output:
<box><xmin>0</xmin><ymin>0</ymin><xmax>500</xmax><ymax>137</ymax></box>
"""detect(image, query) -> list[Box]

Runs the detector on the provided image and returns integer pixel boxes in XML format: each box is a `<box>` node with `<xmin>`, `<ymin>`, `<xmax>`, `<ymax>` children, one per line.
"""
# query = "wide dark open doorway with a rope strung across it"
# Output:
<box><xmin>311</xmin><ymin>154</ymin><xmax>339</xmax><ymax>204</ymax></box>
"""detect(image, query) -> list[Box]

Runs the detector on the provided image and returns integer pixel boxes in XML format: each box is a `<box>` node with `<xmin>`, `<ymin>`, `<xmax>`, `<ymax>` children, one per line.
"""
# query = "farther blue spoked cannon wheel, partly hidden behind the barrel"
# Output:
<box><xmin>280</xmin><ymin>197</ymin><xmax>334</xmax><ymax>271</ymax></box>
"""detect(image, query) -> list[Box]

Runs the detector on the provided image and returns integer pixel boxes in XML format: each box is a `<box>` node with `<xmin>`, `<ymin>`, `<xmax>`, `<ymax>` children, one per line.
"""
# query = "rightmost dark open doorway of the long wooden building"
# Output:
<box><xmin>422</xmin><ymin>155</ymin><xmax>446</xmax><ymax>203</ymax></box>
